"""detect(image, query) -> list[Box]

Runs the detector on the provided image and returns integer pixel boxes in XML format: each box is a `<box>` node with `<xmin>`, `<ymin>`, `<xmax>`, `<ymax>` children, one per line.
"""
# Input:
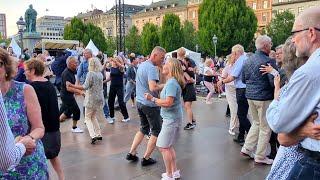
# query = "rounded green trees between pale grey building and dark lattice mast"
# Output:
<box><xmin>63</xmin><ymin>18</ymin><xmax>107</xmax><ymax>52</ymax></box>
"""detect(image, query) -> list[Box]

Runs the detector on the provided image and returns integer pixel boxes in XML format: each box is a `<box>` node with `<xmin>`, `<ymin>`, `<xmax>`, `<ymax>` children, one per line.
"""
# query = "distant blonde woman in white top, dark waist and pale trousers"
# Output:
<box><xmin>203</xmin><ymin>58</ymin><xmax>215</xmax><ymax>104</ymax></box>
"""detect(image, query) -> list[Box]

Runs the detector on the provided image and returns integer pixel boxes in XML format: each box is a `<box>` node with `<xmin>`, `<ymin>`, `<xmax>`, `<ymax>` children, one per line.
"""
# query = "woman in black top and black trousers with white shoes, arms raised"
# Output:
<box><xmin>108</xmin><ymin>57</ymin><xmax>130</xmax><ymax>124</ymax></box>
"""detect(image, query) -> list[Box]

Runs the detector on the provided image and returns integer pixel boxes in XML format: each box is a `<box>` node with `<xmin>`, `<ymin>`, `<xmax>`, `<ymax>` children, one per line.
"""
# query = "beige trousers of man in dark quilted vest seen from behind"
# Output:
<box><xmin>243</xmin><ymin>99</ymin><xmax>271</xmax><ymax>159</ymax></box>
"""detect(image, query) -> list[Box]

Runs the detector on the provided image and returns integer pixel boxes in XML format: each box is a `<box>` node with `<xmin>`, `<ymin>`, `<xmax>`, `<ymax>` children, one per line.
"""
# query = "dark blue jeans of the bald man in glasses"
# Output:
<box><xmin>287</xmin><ymin>155</ymin><xmax>320</xmax><ymax>180</ymax></box>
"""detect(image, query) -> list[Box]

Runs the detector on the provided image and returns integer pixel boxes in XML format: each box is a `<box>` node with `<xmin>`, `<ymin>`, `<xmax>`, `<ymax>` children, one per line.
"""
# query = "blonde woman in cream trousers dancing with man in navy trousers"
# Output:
<box><xmin>221</xmin><ymin>54</ymin><xmax>239</xmax><ymax>136</ymax></box>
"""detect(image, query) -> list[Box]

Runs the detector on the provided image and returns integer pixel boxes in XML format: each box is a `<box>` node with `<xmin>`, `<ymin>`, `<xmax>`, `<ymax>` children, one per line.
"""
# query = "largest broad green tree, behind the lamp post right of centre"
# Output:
<box><xmin>198</xmin><ymin>0</ymin><xmax>257</xmax><ymax>55</ymax></box>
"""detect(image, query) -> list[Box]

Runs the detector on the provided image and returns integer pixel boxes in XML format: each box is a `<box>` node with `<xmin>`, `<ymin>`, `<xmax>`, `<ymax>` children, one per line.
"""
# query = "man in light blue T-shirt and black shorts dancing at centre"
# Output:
<box><xmin>126</xmin><ymin>46</ymin><xmax>166</xmax><ymax>166</ymax></box>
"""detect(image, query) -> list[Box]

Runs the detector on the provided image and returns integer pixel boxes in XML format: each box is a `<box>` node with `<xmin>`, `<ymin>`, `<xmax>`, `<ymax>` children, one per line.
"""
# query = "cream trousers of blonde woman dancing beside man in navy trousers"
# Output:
<box><xmin>226</xmin><ymin>85</ymin><xmax>239</xmax><ymax>131</ymax></box>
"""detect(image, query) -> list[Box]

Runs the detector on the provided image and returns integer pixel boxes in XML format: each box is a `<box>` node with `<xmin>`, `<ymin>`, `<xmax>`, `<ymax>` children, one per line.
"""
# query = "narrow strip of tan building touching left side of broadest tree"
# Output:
<box><xmin>188</xmin><ymin>0</ymin><xmax>202</xmax><ymax>31</ymax></box>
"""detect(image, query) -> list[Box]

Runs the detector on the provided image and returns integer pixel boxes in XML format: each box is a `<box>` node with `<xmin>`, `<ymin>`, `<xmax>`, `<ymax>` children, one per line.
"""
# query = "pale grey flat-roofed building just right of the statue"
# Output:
<box><xmin>36</xmin><ymin>16</ymin><xmax>67</xmax><ymax>40</ymax></box>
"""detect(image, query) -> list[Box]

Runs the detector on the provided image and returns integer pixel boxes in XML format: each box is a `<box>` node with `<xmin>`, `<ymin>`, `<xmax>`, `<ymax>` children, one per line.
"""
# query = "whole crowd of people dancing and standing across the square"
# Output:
<box><xmin>0</xmin><ymin>7</ymin><xmax>320</xmax><ymax>180</ymax></box>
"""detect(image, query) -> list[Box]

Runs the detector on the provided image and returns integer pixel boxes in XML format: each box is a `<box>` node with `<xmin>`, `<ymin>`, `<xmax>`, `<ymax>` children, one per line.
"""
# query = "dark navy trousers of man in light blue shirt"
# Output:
<box><xmin>236</xmin><ymin>88</ymin><xmax>251</xmax><ymax>139</ymax></box>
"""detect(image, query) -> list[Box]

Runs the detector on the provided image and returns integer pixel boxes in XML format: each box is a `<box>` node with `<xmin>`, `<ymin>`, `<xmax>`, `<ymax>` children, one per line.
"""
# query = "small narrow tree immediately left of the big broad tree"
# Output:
<box><xmin>182</xmin><ymin>21</ymin><xmax>197</xmax><ymax>51</ymax></box>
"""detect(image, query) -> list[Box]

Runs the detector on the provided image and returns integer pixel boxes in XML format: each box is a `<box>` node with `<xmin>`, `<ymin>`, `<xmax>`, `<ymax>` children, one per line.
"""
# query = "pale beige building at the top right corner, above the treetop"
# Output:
<box><xmin>272</xmin><ymin>0</ymin><xmax>320</xmax><ymax>16</ymax></box>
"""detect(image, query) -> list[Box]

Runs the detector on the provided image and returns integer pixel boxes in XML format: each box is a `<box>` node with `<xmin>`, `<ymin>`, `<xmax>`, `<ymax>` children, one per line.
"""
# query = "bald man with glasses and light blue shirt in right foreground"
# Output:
<box><xmin>267</xmin><ymin>7</ymin><xmax>320</xmax><ymax>180</ymax></box>
